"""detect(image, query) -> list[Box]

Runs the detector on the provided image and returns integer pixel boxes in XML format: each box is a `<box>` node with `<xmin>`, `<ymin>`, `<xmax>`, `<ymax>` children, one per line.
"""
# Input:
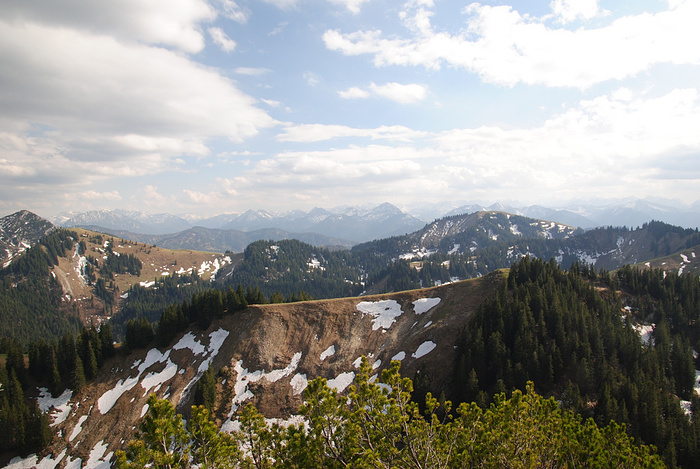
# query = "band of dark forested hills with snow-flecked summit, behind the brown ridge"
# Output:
<box><xmin>212</xmin><ymin>217</ymin><xmax>700</xmax><ymax>298</ymax></box>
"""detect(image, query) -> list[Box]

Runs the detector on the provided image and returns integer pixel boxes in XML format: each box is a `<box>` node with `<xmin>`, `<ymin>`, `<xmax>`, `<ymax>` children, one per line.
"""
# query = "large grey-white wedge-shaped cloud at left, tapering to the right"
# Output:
<box><xmin>0</xmin><ymin>12</ymin><xmax>276</xmax><ymax>210</ymax></box>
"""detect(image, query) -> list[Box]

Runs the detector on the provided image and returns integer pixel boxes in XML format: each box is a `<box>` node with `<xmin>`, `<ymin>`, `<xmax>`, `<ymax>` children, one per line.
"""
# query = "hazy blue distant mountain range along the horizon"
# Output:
<box><xmin>51</xmin><ymin>200</ymin><xmax>700</xmax><ymax>245</ymax></box>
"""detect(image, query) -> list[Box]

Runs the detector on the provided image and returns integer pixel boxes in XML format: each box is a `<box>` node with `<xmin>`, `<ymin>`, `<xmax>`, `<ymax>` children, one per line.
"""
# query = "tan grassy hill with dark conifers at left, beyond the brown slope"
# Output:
<box><xmin>0</xmin><ymin>227</ymin><xmax>233</xmax><ymax>343</ymax></box>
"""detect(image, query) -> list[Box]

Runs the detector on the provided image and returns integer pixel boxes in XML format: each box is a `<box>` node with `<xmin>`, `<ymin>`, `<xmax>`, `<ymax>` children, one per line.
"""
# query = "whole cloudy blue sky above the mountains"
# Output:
<box><xmin>0</xmin><ymin>0</ymin><xmax>700</xmax><ymax>217</ymax></box>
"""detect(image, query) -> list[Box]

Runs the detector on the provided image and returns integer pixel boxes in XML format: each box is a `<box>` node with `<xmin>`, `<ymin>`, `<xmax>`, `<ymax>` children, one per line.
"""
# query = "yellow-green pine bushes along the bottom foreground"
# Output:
<box><xmin>117</xmin><ymin>359</ymin><xmax>664</xmax><ymax>468</ymax></box>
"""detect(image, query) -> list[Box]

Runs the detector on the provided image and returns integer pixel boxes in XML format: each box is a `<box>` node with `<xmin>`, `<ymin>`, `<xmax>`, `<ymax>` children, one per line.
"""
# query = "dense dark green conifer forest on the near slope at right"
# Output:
<box><xmin>455</xmin><ymin>258</ymin><xmax>700</xmax><ymax>467</ymax></box>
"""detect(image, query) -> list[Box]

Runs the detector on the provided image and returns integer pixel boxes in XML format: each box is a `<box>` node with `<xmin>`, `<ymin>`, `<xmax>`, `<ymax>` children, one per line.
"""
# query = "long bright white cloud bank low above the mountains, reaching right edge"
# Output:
<box><xmin>235</xmin><ymin>88</ymin><xmax>700</xmax><ymax>209</ymax></box>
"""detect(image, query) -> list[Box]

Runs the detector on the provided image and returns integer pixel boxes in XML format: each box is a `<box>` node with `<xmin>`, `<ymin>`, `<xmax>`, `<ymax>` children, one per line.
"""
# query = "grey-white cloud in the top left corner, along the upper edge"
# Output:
<box><xmin>0</xmin><ymin>0</ymin><xmax>216</xmax><ymax>53</ymax></box>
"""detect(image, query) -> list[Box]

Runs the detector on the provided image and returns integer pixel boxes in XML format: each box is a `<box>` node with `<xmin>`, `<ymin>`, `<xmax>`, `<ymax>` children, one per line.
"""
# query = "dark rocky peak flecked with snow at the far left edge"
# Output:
<box><xmin>0</xmin><ymin>210</ymin><xmax>54</xmax><ymax>267</ymax></box>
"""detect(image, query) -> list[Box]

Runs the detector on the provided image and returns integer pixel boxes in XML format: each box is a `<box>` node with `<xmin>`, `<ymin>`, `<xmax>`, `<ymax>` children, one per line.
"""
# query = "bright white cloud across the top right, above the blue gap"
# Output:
<box><xmin>323</xmin><ymin>0</ymin><xmax>700</xmax><ymax>88</ymax></box>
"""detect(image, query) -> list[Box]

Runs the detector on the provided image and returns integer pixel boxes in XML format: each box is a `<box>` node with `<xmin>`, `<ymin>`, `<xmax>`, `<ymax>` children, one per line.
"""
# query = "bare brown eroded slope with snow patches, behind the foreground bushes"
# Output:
<box><xmin>13</xmin><ymin>272</ymin><xmax>503</xmax><ymax>467</ymax></box>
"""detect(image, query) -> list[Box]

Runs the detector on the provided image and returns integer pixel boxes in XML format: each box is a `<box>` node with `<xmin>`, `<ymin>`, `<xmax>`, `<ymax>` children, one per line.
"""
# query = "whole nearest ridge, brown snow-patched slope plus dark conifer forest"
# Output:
<box><xmin>5</xmin><ymin>257</ymin><xmax>700</xmax><ymax>468</ymax></box>
